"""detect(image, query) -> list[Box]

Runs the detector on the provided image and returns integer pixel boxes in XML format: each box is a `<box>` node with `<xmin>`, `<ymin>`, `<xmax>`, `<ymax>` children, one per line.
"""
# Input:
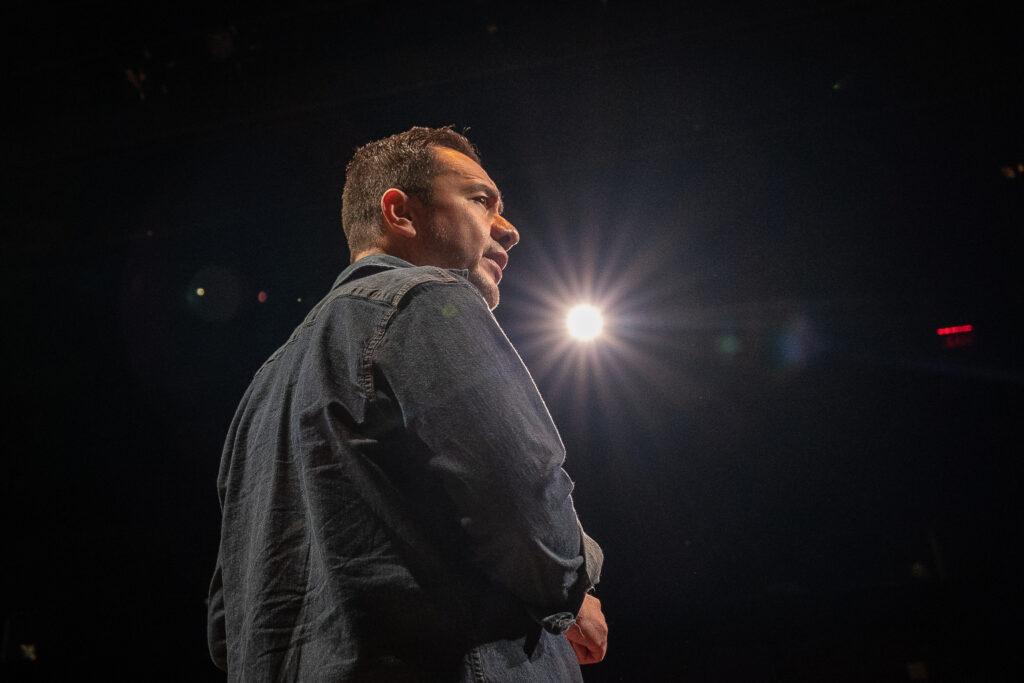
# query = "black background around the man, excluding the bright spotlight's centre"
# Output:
<box><xmin>0</xmin><ymin>0</ymin><xmax>1024</xmax><ymax>681</ymax></box>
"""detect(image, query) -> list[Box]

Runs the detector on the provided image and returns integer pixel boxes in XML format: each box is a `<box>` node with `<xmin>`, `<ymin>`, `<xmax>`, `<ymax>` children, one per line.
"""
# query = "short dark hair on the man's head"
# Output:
<box><xmin>341</xmin><ymin>126</ymin><xmax>480</xmax><ymax>258</ymax></box>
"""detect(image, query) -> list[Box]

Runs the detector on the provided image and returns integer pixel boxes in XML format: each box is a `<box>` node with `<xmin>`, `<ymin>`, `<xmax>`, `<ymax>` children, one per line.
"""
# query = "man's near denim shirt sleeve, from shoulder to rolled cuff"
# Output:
<box><xmin>377</xmin><ymin>282</ymin><xmax>599</xmax><ymax>632</ymax></box>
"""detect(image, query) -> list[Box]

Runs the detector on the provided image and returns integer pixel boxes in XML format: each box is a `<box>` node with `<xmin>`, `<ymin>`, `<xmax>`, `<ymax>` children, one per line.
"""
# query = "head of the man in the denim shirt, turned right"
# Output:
<box><xmin>342</xmin><ymin>128</ymin><xmax>519</xmax><ymax>308</ymax></box>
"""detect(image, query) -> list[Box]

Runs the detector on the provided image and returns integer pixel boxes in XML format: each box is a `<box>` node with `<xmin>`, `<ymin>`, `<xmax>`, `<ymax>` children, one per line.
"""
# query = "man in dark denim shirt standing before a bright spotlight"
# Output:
<box><xmin>209</xmin><ymin>128</ymin><xmax>607</xmax><ymax>681</ymax></box>
